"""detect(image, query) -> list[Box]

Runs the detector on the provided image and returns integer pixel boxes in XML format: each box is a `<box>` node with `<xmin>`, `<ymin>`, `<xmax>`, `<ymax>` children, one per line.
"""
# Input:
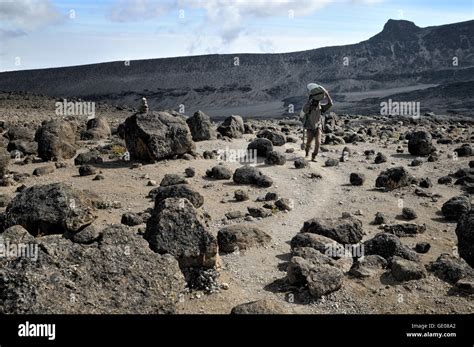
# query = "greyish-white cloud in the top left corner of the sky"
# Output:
<box><xmin>0</xmin><ymin>0</ymin><xmax>61</xmax><ymax>35</ymax></box>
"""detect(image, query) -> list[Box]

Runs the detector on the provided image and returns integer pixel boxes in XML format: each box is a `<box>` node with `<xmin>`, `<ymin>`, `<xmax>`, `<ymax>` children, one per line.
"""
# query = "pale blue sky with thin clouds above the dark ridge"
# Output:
<box><xmin>0</xmin><ymin>0</ymin><xmax>474</xmax><ymax>71</ymax></box>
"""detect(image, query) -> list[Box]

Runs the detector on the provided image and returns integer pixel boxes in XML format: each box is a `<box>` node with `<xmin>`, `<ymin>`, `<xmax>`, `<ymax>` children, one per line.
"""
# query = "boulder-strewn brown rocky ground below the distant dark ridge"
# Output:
<box><xmin>0</xmin><ymin>94</ymin><xmax>474</xmax><ymax>314</ymax></box>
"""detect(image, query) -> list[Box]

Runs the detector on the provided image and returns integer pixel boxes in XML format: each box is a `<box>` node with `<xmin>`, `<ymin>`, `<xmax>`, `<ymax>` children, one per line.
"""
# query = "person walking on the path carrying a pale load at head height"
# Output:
<box><xmin>303</xmin><ymin>83</ymin><xmax>333</xmax><ymax>161</ymax></box>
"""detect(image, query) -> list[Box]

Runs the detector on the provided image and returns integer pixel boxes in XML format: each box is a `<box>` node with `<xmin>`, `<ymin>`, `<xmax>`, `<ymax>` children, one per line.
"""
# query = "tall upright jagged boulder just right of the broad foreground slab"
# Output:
<box><xmin>145</xmin><ymin>198</ymin><xmax>217</xmax><ymax>268</ymax></box>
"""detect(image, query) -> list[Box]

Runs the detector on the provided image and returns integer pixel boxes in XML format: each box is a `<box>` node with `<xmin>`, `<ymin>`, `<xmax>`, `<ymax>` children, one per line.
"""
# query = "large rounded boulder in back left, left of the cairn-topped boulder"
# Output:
<box><xmin>35</xmin><ymin>120</ymin><xmax>76</xmax><ymax>161</ymax></box>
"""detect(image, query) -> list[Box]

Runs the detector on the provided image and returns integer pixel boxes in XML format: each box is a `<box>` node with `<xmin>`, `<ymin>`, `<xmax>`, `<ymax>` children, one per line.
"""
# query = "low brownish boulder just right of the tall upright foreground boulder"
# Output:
<box><xmin>217</xmin><ymin>224</ymin><xmax>272</xmax><ymax>253</ymax></box>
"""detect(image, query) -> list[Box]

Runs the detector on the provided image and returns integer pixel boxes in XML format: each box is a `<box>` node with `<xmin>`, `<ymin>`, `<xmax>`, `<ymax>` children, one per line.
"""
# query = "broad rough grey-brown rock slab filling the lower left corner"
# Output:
<box><xmin>0</xmin><ymin>225</ymin><xmax>185</xmax><ymax>314</ymax></box>
